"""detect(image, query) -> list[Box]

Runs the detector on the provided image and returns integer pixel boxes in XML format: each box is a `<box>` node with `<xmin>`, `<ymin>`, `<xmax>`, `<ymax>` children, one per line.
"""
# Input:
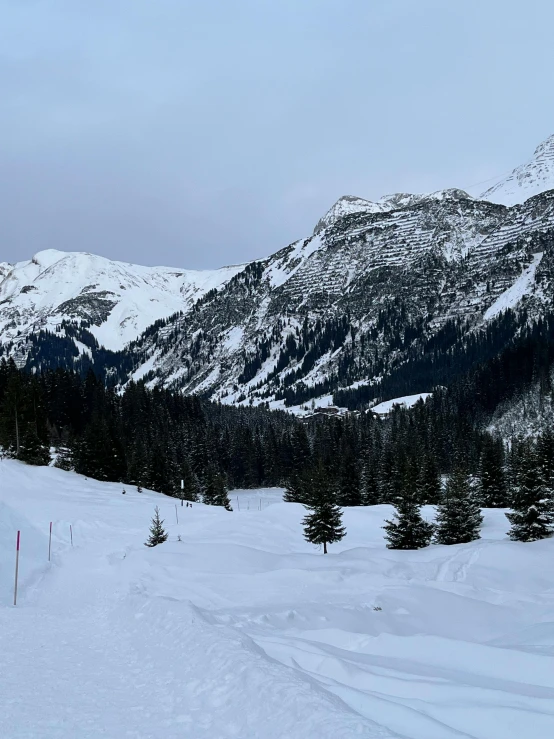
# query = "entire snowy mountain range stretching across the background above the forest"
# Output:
<box><xmin>0</xmin><ymin>136</ymin><xmax>554</xmax><ymax>410</ymax></box>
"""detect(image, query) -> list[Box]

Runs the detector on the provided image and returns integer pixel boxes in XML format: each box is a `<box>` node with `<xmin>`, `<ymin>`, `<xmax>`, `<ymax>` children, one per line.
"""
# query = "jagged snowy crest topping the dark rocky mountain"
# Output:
<box><xmin>314</xmin><ymin>187</ymin><xmax>472</xmax><ymax>234</ymax></box>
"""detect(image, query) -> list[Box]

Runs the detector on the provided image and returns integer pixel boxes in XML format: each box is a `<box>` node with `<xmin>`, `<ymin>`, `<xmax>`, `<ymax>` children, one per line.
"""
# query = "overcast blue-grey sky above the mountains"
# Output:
<box><xmin>0</xmin><ymin>0</ymin><xmax>554</xmax><ymax>268</ymax></box>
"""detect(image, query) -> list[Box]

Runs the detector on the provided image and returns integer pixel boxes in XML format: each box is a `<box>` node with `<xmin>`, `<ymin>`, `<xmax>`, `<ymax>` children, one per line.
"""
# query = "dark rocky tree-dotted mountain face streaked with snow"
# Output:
<box><xmin>124</xmin><ymin>185</ymin><xmax>554</xmax><ymax>414</ymax></box>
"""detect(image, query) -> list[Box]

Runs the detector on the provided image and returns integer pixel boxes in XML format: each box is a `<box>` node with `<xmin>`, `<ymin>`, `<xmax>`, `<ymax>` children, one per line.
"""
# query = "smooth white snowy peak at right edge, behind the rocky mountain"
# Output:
<box><xmin>481</xmin><ymin>135</ymin><xmax>554</xmax><ymax>205</ymax></box>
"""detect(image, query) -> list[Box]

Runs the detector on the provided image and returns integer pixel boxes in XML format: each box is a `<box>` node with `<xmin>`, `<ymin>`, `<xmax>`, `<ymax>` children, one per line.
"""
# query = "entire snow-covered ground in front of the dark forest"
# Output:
<box><xmin>0</xmin><ymin>460</ymin><xmax>554</xmax><ymax>739</ymax></box>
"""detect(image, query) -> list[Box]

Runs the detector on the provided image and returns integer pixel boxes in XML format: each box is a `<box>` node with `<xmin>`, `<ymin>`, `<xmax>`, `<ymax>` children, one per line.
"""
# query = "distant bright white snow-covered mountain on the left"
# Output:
<box><xmin>0</xmin><ymin>249</ymin><xmax>242</xmax><ymax>350</ymax></box>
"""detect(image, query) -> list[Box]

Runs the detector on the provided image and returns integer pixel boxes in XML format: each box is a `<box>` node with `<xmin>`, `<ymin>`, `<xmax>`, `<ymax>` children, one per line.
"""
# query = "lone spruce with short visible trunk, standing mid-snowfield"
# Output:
<box><xmin>302</xmin><ymin>467</ymin><xmax>346</xmax><ymax>554</ymax></box>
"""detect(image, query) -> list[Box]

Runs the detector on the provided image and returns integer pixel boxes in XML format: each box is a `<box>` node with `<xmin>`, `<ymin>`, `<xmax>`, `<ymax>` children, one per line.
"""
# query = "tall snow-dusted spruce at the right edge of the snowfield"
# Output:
<box><xmin>506</xmin><ymin>443</ymin><xmax>554</xmax><ymax>542</ymax></box>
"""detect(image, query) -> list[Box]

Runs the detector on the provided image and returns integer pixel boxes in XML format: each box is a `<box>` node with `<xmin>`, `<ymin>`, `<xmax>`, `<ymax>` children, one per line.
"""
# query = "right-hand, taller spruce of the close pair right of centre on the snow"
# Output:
<box><xmin>435</xmin><ymin>467</ymin><xmax>483</xmax><ymax>544</ymax></box>
